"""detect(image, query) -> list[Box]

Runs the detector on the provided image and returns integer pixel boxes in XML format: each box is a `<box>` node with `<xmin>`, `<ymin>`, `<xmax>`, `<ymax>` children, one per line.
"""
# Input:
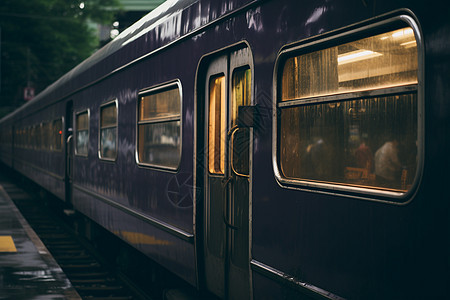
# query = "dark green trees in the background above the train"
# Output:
<box><xmin>0</xmin><ymin>0</ymin><xmax>119</xmax><ymax>117</ymax></box>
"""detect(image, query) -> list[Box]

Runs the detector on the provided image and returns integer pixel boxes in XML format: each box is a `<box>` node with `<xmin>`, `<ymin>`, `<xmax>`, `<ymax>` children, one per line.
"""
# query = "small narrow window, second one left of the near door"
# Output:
<box><xmin>98</xmin><ymin>100</ymin><xmax>117</xmax><ymax>160</ymax></box>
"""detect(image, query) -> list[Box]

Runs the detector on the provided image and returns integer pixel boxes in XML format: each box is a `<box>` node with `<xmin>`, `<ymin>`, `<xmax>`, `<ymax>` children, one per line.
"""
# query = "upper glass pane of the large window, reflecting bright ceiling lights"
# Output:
<box><xmin>281</xmin><ymin>28</ymin><xmax>418</xmax><ymax>101</ymax></box>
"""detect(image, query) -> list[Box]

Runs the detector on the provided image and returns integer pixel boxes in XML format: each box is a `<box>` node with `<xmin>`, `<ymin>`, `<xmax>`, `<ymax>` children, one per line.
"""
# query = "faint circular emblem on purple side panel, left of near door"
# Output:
<box><xmin>167</xmin><ymin>173</ymin><xmax>194</xmax><ymax>208</ymax></box>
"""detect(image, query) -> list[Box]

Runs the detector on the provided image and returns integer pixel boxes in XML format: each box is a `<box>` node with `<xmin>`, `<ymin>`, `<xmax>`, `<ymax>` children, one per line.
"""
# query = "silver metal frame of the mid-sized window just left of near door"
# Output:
<box><xmin>135</xmin><ymin>79</ymin><xmax>183</xmax><ymax>172</ymax></box>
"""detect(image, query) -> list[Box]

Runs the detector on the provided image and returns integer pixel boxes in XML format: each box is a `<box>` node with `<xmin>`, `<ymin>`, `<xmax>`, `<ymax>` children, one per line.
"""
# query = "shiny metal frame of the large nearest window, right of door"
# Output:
<box><xmin>272</xmin><ymin>14</ymin><xmax>425</xmax><ymax>205</ymax></box>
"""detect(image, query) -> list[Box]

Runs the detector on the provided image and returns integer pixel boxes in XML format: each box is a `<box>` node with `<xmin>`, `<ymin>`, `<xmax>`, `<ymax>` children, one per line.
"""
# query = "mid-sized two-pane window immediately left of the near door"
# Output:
<box><xmin>137</xmin><ymin>82</ymin><xmax>181</xmax><ymax>169</ymax></box>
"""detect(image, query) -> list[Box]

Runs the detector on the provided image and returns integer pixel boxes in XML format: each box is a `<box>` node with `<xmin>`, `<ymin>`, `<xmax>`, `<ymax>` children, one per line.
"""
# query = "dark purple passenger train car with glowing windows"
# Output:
<box><xmin>0</xmin><ymin>0</ymin><xmax>450</xmax><ymax>299</ymax></box>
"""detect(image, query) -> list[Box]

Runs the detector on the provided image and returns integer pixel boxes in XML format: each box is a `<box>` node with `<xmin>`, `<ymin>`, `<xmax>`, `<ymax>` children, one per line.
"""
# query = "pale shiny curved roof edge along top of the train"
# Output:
<box><xmin>0</xmin><ymin>0</ymin><xmax>253</xmax><ymax>122</ymax></box>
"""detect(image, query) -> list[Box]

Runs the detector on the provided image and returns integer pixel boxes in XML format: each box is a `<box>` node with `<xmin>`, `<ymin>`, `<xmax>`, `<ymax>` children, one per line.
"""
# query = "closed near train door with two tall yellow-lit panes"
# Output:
<box><xmin>203</xmin><ymin>48</ymin><xmax>253</xmax><ymax>299</ymax></box>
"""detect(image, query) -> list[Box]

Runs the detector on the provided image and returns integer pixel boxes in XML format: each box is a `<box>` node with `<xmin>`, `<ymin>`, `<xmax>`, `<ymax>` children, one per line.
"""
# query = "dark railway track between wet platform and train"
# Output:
<box><xmin>1</xmin><ymin>182</ymin><xmax>150</xmax><ymax>300</ymax></box>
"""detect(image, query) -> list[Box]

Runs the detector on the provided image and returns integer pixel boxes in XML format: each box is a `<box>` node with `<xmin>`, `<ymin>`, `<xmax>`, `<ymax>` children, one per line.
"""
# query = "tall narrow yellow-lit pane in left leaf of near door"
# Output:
<box><xmin>208</xmin><ymin>75</ymin><xmax>227</xmax><ymax>175</ymax></box>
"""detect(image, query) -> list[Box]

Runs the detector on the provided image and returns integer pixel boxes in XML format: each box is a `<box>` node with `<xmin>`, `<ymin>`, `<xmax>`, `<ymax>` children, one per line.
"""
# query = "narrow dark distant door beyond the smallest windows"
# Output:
<box><xmin>64</xmin><ymin>101</ymin><xmax>74</xmax><ymax>203</ymax></box>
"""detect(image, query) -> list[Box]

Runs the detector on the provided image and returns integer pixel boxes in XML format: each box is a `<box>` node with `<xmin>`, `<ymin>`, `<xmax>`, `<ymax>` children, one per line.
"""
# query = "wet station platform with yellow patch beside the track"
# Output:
<box><xmin>0</xmin><ymin>183</ymin><xmax>81</xmax><ymax>299</ymax></box>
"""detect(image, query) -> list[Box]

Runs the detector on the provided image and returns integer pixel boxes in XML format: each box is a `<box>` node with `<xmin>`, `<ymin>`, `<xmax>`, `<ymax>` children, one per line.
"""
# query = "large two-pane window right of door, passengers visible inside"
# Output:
<box><xmin>277</xmin><ymin>27</ymin><xmax>419</xmax><ymax>195</ymax></box>
